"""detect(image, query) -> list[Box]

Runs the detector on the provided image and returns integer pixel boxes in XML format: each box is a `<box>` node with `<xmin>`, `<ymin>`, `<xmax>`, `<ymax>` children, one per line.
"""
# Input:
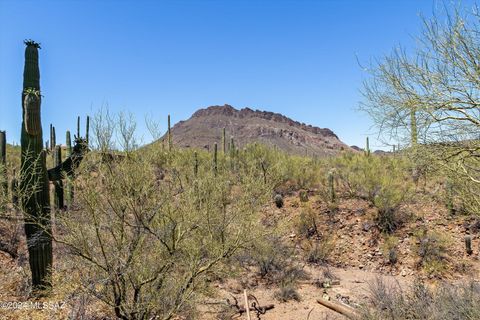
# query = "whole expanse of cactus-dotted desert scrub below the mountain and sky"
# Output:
<box><xmin>0</xmin><ymin>2</ymin><xmax>480</xmax><ymax>320</ymax></box>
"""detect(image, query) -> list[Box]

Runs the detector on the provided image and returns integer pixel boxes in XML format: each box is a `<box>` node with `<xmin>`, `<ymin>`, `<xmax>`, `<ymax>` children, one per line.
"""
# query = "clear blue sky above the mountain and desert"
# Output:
<box><xmin>0</xmin><ymin>0</ymin><xmax>472</xmax><ymax>148</ymax></box>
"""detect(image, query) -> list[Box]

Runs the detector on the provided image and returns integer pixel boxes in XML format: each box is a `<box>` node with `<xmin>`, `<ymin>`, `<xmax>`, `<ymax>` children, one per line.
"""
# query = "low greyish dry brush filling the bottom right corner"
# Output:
<box><xmin>360</xmin><ymin>278</ymin><xmax>480</xmax><ymax>320</ymax></box>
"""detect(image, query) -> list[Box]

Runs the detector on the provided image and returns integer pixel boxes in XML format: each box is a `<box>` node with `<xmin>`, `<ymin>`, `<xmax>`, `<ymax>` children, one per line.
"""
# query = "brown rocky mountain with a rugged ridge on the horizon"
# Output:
<box><xmin>161</xmin><ymin>104</ymin><xmax>353</xmax><ymax>156</ymax></box>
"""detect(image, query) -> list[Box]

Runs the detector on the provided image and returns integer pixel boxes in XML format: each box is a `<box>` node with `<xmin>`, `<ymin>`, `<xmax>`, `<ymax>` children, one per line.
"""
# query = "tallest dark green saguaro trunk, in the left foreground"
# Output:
<box><xmin>20</xmin><ymin>40</ymin><xmax>52</xmax><ymax>292</ymax></box>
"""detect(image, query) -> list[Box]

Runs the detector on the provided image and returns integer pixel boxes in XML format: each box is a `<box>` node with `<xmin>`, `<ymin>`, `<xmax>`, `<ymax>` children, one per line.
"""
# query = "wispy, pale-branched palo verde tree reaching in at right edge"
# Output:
<box><xmin>360</xmin><ymin>6</ymin><xmax>480</xmax><ymax>213</ymax></box>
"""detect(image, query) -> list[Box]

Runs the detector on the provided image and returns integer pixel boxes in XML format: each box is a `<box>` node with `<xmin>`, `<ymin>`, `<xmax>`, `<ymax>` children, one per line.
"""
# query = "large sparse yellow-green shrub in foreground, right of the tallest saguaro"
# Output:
<box><xmin>54</xmin><ymin>114</ymin><xmax>272</xmax><ymax>319</ymax></box>
